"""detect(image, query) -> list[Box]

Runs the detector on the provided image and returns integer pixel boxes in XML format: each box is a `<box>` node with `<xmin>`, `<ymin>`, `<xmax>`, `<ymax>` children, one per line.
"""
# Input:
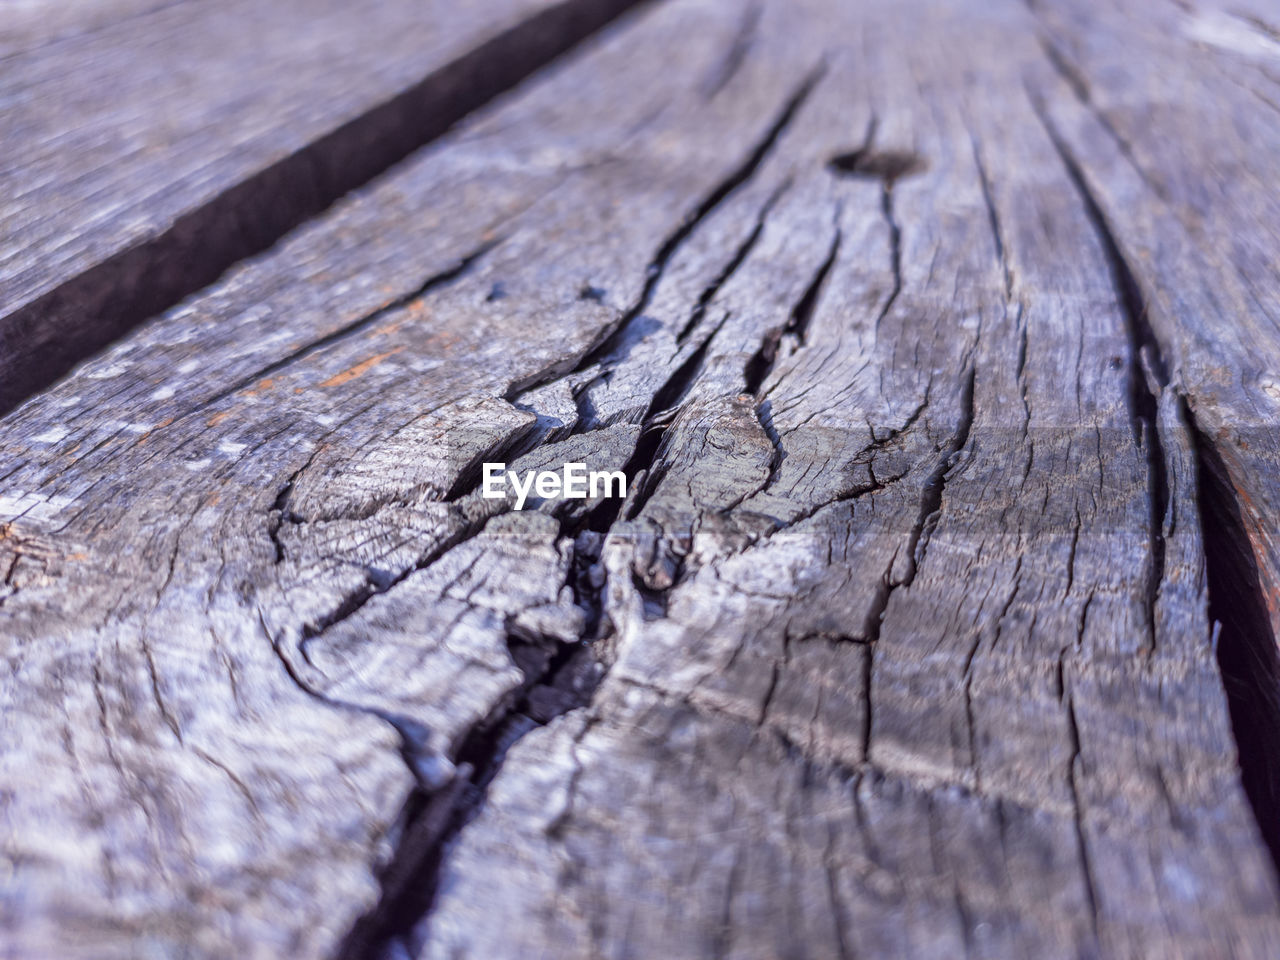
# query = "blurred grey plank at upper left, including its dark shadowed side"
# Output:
<box><xmin>0</xmin><ymin>0</ymin><xmax>650</xmax><ymax>410</ymax></box>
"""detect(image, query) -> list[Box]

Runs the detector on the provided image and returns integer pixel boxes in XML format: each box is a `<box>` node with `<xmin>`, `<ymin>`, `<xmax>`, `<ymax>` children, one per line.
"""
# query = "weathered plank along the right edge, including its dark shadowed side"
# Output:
<box><xmin>1037</xmin><ymin>3</ymin><xmax>1280</xmax><ymax>865</ymax></box>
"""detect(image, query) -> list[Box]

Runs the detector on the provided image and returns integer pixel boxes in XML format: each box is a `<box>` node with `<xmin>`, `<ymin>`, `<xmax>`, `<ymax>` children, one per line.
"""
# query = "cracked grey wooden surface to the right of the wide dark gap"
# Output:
<box><xmin>0</xmin><ymin>0</ymin><xmax>1280</xmax><ymax>959</ymax></box>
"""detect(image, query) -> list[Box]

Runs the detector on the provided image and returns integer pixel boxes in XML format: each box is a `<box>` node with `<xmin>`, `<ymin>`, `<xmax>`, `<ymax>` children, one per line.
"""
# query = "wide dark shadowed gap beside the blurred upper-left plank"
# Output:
<box><xmin>0</xmin><ymin>0</ymin><xmax>653</xmax><ymax>416</ymax></box>
